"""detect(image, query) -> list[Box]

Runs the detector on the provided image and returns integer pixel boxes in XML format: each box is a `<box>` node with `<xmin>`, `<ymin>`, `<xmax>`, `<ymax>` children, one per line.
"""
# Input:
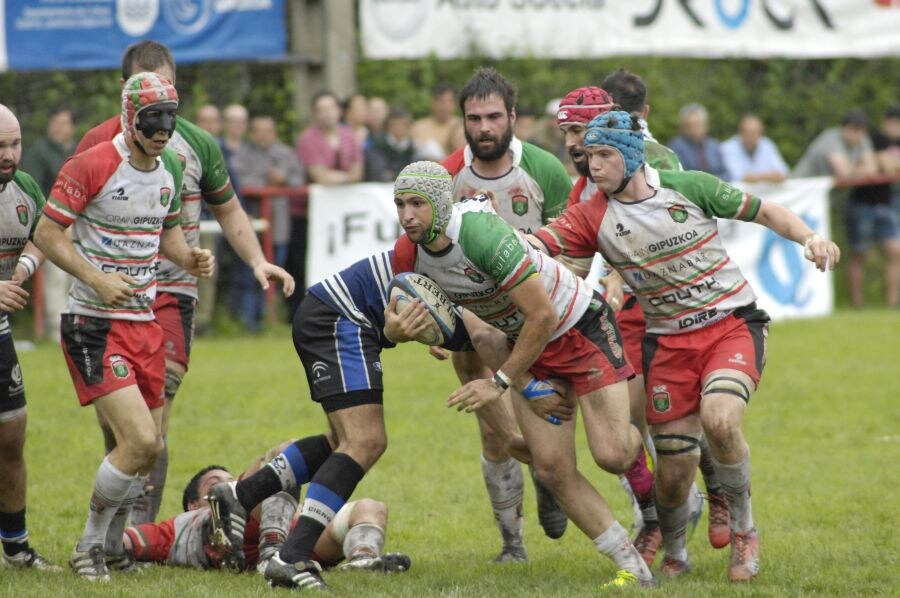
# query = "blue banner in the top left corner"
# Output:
<box><xmin>0</xmin><ymin>0</ymin><xmax>287</xmax><ymax>71</ymax></box>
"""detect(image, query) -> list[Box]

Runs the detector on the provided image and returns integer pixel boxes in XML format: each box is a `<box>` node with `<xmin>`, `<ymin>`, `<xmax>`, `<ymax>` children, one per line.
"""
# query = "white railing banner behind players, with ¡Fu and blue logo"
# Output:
<box><xmin>306</xmin><ymin>177</ymin><xmax>834</xmax><ymax>320</ymax></box>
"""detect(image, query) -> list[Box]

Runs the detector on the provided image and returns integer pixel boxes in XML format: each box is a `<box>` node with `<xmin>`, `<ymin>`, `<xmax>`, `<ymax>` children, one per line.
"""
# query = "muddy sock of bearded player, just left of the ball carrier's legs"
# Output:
<box><xmin>481</xmin><ymin>455</ymin><xmax>525</xmax><ymax>548</ymax></box>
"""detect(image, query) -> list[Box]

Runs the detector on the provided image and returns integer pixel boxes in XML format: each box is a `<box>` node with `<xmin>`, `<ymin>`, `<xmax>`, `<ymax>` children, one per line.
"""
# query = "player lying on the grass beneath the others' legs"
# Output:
<box><xmin>125</xmin><ymin>442</ymin><xmax>410</xmax><ymax>573</ymax></box>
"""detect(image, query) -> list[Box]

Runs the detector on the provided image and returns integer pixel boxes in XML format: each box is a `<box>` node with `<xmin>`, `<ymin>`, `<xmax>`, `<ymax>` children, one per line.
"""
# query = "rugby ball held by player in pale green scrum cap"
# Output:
<box><xmin>388</xmin><ymin>272</ymin><xmax>456</xmax><ymax>346</ymax></box>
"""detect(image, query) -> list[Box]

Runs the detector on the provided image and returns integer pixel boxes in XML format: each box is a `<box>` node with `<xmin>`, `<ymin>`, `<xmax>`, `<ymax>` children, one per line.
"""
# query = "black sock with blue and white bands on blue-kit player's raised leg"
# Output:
<box><xmin>236</xmin><ymin>434</ymin><xmax>331</xmax><ymax>513</ymax></box>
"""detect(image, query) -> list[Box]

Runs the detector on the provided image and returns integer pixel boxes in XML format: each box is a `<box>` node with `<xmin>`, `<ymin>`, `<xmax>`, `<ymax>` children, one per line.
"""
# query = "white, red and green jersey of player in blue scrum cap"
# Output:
<box><xmin>537</xmin><ymin>164</ymin><xmax>761</xmax><ymax>334</ymax></box>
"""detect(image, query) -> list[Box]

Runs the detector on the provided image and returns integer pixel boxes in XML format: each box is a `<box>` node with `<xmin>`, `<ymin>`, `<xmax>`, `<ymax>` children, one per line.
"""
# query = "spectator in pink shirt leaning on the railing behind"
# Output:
<box><xmin>295</xmin><ymin>91</ymin><xmax>363</xmax><ymax>185</ymax></box>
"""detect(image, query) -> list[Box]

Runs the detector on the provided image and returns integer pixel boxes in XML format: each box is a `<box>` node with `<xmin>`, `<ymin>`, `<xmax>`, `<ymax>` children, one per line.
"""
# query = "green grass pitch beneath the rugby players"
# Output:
<box><xmin>0</xmin><ymin>311</ymin><xmax>900</xmax><ymax>598</ymax></box>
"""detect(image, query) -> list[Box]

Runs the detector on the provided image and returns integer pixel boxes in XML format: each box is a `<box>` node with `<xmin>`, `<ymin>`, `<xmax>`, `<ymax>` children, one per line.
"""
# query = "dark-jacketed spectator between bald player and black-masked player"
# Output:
<box><xmin>22</xmin><ymin>108</ymin><xmax>77</xmax><ymax>340</ymax></box>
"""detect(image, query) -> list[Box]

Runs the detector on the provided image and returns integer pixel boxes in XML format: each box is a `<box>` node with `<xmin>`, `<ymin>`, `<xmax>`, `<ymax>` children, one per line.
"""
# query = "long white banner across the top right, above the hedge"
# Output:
<box><xmin>360</xmin><ymin>0</ymin><xmax>900</xmax><ymax>59</ymax></box>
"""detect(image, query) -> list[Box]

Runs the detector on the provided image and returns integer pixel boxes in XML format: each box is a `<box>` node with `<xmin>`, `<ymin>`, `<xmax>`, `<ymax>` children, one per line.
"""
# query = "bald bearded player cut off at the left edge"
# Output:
<box><xmin>0</xmin><ymin>104</ymin><xmax>60</xmax><ymax>571</ymax></box>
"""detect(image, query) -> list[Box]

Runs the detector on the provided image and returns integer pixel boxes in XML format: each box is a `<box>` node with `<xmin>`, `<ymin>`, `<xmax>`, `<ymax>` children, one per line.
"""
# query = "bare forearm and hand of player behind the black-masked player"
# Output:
<box><xmin>207</xmin><ymin>197</ymin><xmax>295</xmax><ymax>297</ymax></box>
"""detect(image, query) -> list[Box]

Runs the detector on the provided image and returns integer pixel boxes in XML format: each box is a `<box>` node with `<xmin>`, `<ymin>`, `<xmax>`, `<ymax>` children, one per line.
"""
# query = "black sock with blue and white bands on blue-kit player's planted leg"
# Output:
<box><xmin>278</xmin><ymin>453</ymin><xmax>366</xmax><ymax>563</ymax></box>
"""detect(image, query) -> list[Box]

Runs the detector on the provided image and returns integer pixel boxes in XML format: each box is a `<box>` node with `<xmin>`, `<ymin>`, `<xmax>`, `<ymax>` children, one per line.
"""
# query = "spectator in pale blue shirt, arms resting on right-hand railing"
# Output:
<box><xmin>721</xmin><ymin>114</ymin><xmax>788</xmax><ymax>183</ymax></box>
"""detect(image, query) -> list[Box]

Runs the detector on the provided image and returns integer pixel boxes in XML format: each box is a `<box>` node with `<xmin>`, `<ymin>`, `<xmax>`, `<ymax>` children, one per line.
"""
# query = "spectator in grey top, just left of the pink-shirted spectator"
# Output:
<box><xmin>229</xmin><ymin>116</ymin><xmax>305</xmax><ymax>332</ymax></box>
